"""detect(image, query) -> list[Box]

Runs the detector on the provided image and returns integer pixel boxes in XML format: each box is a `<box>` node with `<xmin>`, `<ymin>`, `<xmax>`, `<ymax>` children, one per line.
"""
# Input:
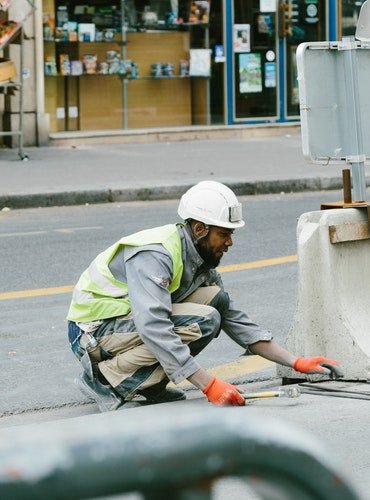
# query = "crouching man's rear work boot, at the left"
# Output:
<box><xmin>75</xmin><ymin>371</ymin><xmax>124</xmax><ymax>413</ymax></box>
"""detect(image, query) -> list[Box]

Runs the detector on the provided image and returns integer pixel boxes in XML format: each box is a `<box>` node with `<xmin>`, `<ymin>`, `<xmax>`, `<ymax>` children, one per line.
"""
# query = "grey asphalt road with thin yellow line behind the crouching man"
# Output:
<box><xmin>0</xmin><ymin>192</ymin><xmax>337</xmax><ymax>415</ymax></box>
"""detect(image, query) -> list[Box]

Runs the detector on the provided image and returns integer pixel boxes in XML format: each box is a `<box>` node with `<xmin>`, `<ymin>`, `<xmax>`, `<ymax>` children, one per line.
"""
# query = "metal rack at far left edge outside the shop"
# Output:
<box><xmin>0</xmin><ymin>0</ymin><xmax>36</xmax><ymax>160</ymax></box>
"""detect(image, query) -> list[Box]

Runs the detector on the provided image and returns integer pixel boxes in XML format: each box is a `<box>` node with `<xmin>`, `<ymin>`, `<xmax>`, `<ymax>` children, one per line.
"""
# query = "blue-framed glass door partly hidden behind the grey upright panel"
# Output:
<box><xmin>279</xmin><ymin>0</ymin><xmax>328</xmax><ymax>118</ymax></box>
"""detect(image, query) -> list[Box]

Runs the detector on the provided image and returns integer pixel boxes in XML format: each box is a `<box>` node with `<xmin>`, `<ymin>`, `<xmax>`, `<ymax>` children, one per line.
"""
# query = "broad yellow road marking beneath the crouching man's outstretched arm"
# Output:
<box><xmin>171</xmin><ymin>356</ymin><xmax>275</xmax><ymax>387</ymax></box>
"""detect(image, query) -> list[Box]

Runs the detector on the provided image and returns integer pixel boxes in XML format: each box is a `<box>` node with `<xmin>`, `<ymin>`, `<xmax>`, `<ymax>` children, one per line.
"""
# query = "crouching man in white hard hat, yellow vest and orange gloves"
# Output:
<box><xmin>68</xmin><ymin>181</ymin><xmax>338</xmax><ymax>411</ymax></box>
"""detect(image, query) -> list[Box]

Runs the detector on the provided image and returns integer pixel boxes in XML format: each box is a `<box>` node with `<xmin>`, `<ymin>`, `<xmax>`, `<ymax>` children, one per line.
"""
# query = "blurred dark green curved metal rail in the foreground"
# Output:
<box><xmin>0</xmin><ymin>402</ymin><xmax>358</xmax><ymax>500</ymax></box>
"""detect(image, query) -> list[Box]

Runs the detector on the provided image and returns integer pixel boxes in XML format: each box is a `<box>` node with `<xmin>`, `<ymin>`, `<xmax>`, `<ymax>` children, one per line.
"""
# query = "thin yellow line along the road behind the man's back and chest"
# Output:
<box><xmin>0</xmin><ymin>255</ymin><xmax>298</xmax><ymax>300</ymax></box>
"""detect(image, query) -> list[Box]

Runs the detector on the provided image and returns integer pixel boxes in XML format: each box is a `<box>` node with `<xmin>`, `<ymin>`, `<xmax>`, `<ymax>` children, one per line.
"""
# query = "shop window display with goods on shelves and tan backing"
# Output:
<box><xmin>43</xmin><ymin>0</ymin><xmax>210</xmax><ymax>131</ymax></box>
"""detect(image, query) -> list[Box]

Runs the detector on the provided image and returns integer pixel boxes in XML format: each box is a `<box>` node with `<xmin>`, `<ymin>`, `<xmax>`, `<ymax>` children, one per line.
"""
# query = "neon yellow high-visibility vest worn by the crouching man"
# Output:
<box><xmin>67</xmin><ymin>224</ymin><xmax>183</xmax><ymax>322</ymax></box>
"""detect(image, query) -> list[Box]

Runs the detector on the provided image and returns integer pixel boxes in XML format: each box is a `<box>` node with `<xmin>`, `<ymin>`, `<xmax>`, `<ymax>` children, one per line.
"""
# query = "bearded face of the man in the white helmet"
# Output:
<box><xmin>197</xmin><ymin>226</ymin><xmax>234</xmax><ymax>267</ymax></box>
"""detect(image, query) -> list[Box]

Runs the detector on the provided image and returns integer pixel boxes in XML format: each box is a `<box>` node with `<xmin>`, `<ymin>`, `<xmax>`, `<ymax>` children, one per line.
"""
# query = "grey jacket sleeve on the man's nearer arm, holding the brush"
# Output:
<box><xmin>125</xmin><ymin>247</ymin><xmax>200</xmax><ymax>383</ymax></box>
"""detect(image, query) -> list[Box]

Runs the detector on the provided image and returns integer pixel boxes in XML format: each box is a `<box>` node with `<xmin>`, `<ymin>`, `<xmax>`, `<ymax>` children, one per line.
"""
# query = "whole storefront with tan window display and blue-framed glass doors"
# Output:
<box><xmin>0</xmin><ymin>0</ymin><xmax>362</xmax><ymax>143</ymax></box>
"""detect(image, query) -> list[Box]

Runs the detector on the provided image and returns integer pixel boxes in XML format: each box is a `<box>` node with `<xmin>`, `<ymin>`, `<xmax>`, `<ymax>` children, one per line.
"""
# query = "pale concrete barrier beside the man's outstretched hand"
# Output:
<box><xmin>277</xmin><ymin>208</ymin><xmax>370</xmax><ymax>380</ymax></box>
